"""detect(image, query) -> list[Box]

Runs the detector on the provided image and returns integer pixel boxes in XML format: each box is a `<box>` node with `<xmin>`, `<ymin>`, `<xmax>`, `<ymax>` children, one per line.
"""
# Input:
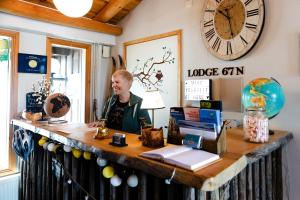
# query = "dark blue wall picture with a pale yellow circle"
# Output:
<box><xmin>18</xmin><ymin>53</ymin><xmax>47</xmax><ymax>74</ymax></box>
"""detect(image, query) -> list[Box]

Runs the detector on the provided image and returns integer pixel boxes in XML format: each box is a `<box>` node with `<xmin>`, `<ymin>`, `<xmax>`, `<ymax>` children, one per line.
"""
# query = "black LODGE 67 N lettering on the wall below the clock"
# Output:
<box><xmin>187</xmin><ymin>66</ymin><xmax>244</xmax><ymax>77</ymax></box>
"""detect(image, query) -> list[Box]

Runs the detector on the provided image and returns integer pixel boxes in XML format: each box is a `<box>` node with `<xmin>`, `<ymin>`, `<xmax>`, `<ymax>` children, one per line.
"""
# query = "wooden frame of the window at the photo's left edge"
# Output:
<box><xmin>0</xmin><ymin>29</ymin><xmax>20</xmax><ymax>177</ymax></box>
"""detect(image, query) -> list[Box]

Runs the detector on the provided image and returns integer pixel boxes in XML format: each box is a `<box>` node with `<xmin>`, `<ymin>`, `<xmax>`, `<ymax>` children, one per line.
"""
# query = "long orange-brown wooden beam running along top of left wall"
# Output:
<box><xmin>0</xmin><ymin>0</ymin><xmax>122</xmax><ymax>35</ymax></box>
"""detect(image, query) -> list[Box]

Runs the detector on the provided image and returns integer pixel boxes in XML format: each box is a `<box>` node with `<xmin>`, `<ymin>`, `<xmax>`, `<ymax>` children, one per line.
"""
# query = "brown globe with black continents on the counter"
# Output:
<box><xmin>44</xmin><ymin>93</ymin><xmax>71</xmax><ymax>118</ymax></box>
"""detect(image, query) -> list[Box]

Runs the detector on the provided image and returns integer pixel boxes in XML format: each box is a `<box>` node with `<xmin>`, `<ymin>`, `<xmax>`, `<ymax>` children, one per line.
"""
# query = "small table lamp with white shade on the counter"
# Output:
<box><xmin>141</xmin><ymin>90</ymin><xmax>165</xmax><ymax>127</ymax></box>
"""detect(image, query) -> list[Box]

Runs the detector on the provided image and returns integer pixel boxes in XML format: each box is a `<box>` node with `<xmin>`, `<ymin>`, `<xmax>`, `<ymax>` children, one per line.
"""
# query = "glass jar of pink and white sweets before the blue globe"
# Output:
<box><xmin>244</xmin><ymin>107</ymin><xmax>269</xmax><ymax>143</ymax></box>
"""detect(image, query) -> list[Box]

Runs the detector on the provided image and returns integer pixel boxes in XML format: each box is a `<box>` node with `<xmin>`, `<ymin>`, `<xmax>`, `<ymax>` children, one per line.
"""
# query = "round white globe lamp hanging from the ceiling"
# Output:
<box><xmin>53</xmin><ymin>0</ymin><xmax>93</xmax><ymax>17</ymax></box>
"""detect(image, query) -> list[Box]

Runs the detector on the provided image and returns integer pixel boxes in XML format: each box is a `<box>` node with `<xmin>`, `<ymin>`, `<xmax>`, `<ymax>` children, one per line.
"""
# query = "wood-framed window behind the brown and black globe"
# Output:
<box><xmin>47</xmin><ymin>38</ymin><xmax>91</xmax><ymax>123</ymax></box>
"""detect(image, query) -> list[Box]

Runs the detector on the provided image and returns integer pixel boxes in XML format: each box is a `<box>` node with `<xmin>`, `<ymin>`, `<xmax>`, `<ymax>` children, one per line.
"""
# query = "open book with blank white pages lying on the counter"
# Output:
<box><xmin>141</xmin><ymin>145</ymin><xmax>220</xmax><ymax>171</ymax></box>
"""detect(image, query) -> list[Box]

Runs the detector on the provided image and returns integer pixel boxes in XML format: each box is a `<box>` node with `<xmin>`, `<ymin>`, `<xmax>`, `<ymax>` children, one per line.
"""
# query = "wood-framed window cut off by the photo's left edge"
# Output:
<box><xmin>0</xmin><ymin>29</ymin><xmax>19</xmax><ymax>176</ymax></box>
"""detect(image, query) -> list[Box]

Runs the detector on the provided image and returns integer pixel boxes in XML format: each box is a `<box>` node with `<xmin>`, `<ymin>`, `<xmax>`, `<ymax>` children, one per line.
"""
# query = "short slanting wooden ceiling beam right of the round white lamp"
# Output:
<box><xmin>94</xmin><ymin>0</ymin><xmax>138</xmax><ymax>22</ymax></box>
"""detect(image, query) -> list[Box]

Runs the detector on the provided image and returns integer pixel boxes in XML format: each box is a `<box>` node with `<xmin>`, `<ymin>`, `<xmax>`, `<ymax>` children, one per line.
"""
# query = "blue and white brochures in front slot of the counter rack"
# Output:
<box><xmin>178</xmin><ymin>120</ymin><xmax>218</xmax><ymax>140</ymax></box>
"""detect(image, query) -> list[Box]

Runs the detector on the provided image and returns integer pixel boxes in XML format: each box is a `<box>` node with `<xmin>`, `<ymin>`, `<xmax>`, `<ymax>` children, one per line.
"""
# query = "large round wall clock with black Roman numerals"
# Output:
<box><xmin>201</xmin><ymin>0</ymin><xmax>264</xmax><ymax>60</ymax></box>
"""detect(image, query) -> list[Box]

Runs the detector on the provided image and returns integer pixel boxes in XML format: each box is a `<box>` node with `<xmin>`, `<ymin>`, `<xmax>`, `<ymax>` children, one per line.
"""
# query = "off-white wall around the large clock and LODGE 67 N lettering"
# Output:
<box><xmin>114</xmin><ymin>0</ymin><xmax>300</xmax><ymax>200</ymax></box>
